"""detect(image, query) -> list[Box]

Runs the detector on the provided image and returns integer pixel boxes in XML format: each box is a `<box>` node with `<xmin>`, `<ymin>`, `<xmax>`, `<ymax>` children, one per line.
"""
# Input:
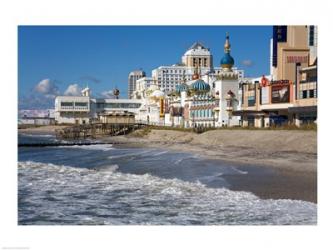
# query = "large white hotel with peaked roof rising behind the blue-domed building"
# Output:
<box><xmin>152</xmin><ymin>42</ymin><xmax>244</xmax><ymax>93</ymax></box>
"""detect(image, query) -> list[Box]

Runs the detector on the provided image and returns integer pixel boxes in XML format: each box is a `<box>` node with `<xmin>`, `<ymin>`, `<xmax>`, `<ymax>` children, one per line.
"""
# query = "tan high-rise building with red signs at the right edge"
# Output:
<box><xmin>233</xmin><ymin>26</ymin><xmax>317</xmax><ymax>127</ymax></box>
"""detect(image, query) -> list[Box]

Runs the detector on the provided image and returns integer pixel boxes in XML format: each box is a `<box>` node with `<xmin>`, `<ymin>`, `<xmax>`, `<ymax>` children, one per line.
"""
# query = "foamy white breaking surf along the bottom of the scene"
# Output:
<box><xmin>18</xmin><ymin>161</ymin><xmax>317</xmax><ymax>225</ymax></box>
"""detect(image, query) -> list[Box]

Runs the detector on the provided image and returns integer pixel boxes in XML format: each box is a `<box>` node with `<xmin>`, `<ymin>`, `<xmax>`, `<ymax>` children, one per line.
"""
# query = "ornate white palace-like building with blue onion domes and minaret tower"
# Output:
<box><xmin>163</xmin><ymin>35</ymin><xmax>240</xmax><ymax>128</ymax></box>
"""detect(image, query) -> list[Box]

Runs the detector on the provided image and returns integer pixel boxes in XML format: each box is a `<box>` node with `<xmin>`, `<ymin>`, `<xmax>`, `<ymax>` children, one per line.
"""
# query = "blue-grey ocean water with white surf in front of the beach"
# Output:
<box><xmin>18</xmin><ymin>134</ymin><xmax>317</xmax><ymax>225</ymax></box>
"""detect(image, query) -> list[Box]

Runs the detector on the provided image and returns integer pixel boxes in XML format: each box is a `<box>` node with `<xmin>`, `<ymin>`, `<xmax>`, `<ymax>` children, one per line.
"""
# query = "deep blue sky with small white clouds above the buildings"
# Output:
<box><xmin>18</xmin><ymin>26</ymin><xmax>272</xmax><ymax>109</ymax></box>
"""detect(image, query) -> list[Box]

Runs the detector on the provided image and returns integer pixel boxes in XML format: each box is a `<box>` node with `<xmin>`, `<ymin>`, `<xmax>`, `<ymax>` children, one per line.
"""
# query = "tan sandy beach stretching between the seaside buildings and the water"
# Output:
<box><xmin>19</xmin><ymin>126</ymin><xmax>317</xmax><ymax>203</ymax></box>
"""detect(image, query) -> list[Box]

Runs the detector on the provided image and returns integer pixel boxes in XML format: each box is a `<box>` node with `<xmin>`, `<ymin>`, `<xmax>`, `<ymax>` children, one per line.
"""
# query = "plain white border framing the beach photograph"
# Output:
<box><xmin>0</xmin><ymin>0</ymin><xmax>333</xmax><ymax>250</ymax></box>
